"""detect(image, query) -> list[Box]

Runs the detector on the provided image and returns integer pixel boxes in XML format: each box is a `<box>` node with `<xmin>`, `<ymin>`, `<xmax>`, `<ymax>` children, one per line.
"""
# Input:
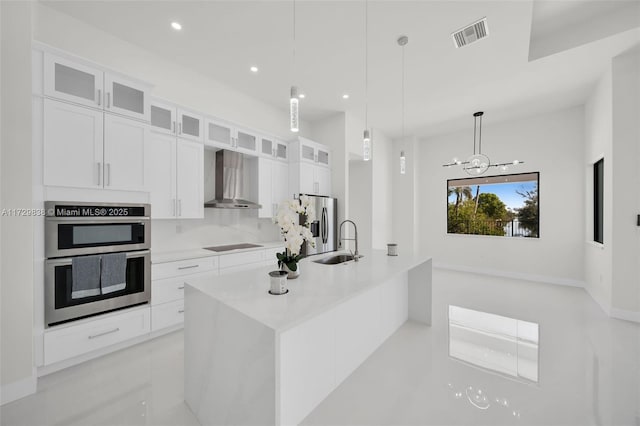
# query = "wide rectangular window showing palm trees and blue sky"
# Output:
<box><xmin>447</xmin><ymin>173</ymin><xmax>540</xmax><ymax>238</ymax></box>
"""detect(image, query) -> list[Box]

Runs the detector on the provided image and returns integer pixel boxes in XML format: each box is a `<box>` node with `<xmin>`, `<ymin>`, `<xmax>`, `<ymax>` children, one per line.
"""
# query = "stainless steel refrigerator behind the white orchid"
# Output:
<box><xmin>302</xmin><ymin>195</ymin><xmax>338</xmax><ymax>256</ymax></box>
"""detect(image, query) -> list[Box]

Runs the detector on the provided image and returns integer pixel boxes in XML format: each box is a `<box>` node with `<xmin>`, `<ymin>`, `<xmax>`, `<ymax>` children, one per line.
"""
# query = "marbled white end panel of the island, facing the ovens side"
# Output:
<box><xmin>184</xmin><ymin>286</ymin><xmax>276</xmax><ymax>425</ymax></box>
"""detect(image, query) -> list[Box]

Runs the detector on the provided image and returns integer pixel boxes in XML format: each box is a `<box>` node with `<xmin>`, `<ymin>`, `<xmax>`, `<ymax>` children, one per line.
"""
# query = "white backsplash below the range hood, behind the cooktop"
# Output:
<box><xmin>151</xmin><ymin>208</ymin><xmax>282</xmax><ymax>251</ymax></box>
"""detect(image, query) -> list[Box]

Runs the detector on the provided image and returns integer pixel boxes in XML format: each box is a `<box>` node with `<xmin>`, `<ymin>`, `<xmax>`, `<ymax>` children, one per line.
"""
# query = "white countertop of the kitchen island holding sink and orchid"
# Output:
<box><xmin>186</xmin><ymin>250</ymin><xmax>429</xmax><ymax>331</ymax></box>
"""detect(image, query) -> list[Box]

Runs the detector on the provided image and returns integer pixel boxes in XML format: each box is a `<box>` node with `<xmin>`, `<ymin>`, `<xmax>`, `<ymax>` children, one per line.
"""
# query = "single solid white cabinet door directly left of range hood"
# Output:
<box><xmin>176</xmin><ymin>140</ymin><xmax>204</xmax><ymax>219</ymax></box>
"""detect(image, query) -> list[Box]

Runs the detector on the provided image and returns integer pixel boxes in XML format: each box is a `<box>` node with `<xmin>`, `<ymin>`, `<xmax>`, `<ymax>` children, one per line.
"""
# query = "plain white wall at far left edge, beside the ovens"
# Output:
<box><xmin>0</xmin><ymin>1</ymin><xmax>36</xmax><ymax>403</ymax></box>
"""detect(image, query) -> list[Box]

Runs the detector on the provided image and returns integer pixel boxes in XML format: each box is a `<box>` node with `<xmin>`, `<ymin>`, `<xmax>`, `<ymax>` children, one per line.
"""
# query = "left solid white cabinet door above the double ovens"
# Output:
<box><xmin>43</xmin><ymin>99</ymin><xmax>104</xmax><ymax>188</ymax></box>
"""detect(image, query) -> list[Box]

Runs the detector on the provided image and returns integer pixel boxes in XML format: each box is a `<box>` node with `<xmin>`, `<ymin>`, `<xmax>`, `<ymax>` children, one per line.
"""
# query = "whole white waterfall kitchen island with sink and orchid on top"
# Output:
<box><xmin>184</xmin><ymin>251</ymin><xmax>431</xmax><ymax>425</ymax></box>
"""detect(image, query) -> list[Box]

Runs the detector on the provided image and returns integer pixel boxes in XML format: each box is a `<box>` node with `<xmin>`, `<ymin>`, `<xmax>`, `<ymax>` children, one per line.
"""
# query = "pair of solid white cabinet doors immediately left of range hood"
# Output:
<box><xmin>145</xmin><ymin>131</ymin><xmax>204</xmax><ymax>219</ymax></box>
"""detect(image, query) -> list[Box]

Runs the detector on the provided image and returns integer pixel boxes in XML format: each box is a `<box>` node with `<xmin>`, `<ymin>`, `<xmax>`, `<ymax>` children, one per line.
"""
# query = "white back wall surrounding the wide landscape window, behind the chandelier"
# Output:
<box><xmin>416</xmin><ymin>107</ymin><xmax>585</xmax><ymax>285</ymax></box>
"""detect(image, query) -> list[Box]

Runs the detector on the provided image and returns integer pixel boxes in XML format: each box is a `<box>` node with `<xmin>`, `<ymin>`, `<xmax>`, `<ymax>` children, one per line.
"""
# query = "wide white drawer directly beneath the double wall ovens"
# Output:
<box><xmin>44</xmin><ymin>307</ymin><xmax>151</xmax><ymax>365</ymax></box>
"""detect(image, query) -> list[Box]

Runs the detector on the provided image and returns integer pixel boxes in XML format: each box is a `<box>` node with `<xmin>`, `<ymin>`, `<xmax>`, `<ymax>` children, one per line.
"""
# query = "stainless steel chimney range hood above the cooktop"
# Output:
<box><xmin>204</xmin><ymin>149</ymin><xmax>262</xmax><ymax>209</ymax></box>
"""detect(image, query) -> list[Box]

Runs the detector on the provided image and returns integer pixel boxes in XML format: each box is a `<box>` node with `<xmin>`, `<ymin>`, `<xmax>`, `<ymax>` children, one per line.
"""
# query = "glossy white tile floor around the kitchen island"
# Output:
<box><xmin>0</xmin><ymin>270</ymin><xmax>640</xmax><ymax>426</ymax></box>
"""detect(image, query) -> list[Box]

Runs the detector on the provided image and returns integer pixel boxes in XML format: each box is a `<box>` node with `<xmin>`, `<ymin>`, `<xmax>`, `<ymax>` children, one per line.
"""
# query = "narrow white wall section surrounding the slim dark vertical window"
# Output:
<box><xmin>584</xmin><ymin>67</ymin><xmax>613</xmax><ymax>313</ymax></box>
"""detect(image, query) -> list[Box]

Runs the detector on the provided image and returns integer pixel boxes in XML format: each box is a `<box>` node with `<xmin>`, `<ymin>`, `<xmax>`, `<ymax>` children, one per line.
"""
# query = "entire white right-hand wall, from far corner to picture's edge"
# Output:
<box><xmin>584</xmin><ymin>49</ymin><xmax>640</xmax><ymax>321</ymax></box>
